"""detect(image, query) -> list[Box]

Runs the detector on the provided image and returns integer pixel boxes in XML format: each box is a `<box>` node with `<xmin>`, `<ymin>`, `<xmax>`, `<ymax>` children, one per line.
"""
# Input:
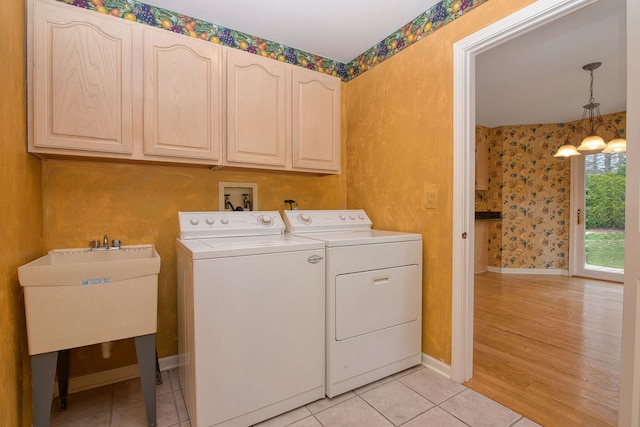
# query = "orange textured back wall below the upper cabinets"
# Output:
<box><xmin>42</xmin><ymin>142</ymin><xmax>346</xmax><ymax>377</ymax></box>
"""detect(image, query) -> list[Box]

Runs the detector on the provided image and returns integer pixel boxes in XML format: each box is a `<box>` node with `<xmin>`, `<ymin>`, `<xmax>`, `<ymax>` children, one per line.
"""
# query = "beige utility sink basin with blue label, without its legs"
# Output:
<box><xmin>18</xmin><ymin>245</ymin><xmax>160</xmax><ymax>355</ymax></box>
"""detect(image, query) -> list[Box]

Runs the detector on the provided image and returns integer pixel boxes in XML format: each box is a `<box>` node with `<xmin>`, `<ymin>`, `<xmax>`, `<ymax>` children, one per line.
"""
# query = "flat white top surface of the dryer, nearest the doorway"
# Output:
<box><xmin>298</xmin><ymin>230</ymin><xmax>422</xmax><ymax>247</ymax></box>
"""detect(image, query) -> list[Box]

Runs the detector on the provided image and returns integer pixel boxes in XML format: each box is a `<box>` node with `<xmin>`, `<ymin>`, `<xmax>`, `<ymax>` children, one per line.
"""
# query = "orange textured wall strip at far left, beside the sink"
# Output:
<box><xmin>0</xmin><ymin>0</ymin><xmax>43</xmax><ymax>426</ymax></box>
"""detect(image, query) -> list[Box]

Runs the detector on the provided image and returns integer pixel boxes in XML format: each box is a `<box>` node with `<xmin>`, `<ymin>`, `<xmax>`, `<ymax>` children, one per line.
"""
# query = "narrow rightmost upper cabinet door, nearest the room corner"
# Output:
<box><xmin>293</xmin><ymin>67</ymin><xmax>340</xmax><ymax>173</ymax></box>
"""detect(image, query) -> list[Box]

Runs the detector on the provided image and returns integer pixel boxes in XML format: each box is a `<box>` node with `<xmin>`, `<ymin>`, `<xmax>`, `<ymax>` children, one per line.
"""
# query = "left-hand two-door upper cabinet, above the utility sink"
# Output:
<box><xmin>28</xmin><ymin>0</ymin><xmax>223</xmax><ymax>165</ymax></box>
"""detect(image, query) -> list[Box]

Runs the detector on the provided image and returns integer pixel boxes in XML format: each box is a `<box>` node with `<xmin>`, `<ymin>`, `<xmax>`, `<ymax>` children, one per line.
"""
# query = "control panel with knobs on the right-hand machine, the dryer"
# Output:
<box><xmin>284</xmin><ymin>209</ymin><xmax>372</xmax><ymax>233</ymax></box>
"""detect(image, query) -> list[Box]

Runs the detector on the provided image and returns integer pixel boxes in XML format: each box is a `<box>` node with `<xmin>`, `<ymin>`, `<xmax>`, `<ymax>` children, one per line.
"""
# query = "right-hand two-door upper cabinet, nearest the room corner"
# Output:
<box><xmin>225</xmin><ymin>49</ymin><xmax>341</xmax><ymax>173</ymax></box>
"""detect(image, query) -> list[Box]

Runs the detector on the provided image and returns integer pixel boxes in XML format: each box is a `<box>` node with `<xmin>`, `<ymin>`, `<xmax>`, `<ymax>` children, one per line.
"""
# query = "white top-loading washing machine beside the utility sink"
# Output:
<box><xmin>177</xmin><ymin>211</ymin><xmax>325</xmax><ymax>427</ymax></box>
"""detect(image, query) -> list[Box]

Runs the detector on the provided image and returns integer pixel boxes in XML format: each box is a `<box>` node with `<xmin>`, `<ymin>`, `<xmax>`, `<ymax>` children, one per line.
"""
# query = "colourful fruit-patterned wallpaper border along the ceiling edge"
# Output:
<box><xmin>57</xmin><ymin>0</ymin><xmax>488</xmax><ymax>81</ymax></box>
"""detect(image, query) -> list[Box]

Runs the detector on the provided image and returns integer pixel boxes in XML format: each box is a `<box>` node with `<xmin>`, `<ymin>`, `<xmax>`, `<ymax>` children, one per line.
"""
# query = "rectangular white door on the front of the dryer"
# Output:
<box><xmin>335</xmin><ymin>265</ymin><xmax>420</xmax><ymax>341</ymax></box>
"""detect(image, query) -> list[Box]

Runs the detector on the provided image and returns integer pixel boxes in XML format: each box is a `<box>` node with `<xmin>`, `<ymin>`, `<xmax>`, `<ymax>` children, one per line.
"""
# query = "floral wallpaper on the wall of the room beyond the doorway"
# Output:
<box><xmin>475</xmin><ymin>112</ymin><xmax>626</xmax><ymax>270</ymax></box>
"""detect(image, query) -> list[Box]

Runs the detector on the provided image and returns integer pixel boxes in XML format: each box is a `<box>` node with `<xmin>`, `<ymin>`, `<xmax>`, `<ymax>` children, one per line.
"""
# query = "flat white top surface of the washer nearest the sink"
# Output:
<box><xmin>178</xmin><ymin>234</ymin><xmax>325</xmax><ymax>260</ymax></box>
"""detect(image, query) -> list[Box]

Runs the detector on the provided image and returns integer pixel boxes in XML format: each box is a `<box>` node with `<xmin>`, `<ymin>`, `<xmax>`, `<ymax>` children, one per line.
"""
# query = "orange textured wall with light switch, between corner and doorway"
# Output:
<box><xmin>346</xmin><ymin>0</ymin><xmax>533</xmax><ymax>364</ymax></box>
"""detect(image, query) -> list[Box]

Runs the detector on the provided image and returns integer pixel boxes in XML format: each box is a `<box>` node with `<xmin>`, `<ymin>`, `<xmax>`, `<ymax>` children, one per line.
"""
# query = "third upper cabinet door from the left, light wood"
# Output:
<box><xmin>226</xmin><ymin>49</ymin><xmax>291</xmax><ymax>168</ymax></box>
